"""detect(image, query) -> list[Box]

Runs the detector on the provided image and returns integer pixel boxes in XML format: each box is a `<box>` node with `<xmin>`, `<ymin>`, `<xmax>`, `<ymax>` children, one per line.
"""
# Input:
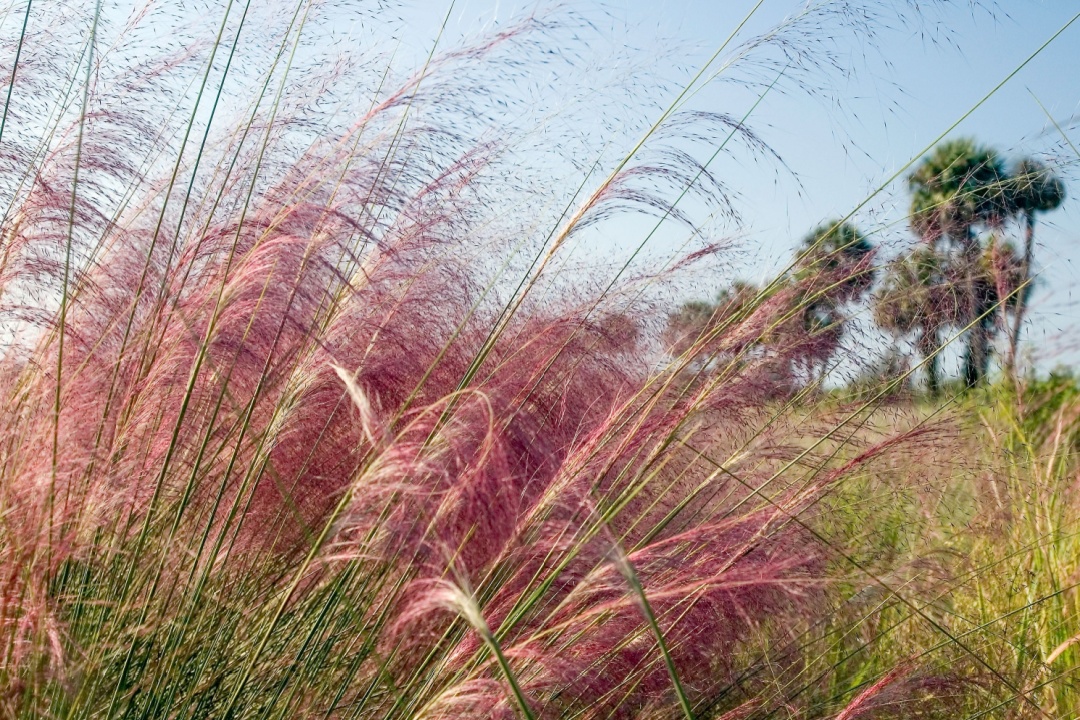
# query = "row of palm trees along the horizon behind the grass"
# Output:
<box><xmin>665</xmin><ymin>138</ymin><xmax>1065</xmax><ymax>395</ymax></box>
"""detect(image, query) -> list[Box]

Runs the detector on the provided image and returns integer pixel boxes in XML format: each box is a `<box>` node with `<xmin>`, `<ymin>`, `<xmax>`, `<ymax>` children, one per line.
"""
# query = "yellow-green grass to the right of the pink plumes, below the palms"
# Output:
<box><xmin>821</xmin><ymin>388</ymin><xmax>1080</xmax><ymax>718</ymax></box>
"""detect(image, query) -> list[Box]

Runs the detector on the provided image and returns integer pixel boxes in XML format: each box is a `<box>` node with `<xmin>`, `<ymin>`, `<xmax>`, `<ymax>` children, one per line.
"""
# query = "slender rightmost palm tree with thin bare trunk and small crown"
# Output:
<box><xmin>1005</xmin><ymin>158</ymin><xmax>1065</xmax><ymax>375</ymax></box>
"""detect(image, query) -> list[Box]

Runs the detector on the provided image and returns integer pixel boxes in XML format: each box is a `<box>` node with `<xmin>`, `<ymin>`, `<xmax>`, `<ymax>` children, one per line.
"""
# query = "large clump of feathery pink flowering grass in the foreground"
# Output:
<box><xmin>0</xmin><ymin>3</ymin><xmax>1054</xmax><ymax>719</ymax></box>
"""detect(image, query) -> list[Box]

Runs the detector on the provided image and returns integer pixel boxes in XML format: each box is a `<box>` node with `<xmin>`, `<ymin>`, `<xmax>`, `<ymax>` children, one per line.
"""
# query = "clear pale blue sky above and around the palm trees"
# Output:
<box><xmin>403</xmin><ymin>0</ymin><xmax>1080</xmax><ymax>377</ymax></box>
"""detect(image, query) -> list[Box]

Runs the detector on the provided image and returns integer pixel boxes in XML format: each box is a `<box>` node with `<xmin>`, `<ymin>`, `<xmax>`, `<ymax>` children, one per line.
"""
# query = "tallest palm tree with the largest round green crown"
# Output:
<box><xmin>908</xmin><ymin>138</ymin><xmax>1013</xmax><ymax>388</ymax></box>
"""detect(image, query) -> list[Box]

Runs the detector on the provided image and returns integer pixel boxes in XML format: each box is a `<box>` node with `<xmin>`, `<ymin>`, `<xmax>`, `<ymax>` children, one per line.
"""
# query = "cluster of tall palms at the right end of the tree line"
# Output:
<box><xmin>875</xmin><ymin>138</ymin><xmax>1065</xmax><ymax>391</ymax></box>
